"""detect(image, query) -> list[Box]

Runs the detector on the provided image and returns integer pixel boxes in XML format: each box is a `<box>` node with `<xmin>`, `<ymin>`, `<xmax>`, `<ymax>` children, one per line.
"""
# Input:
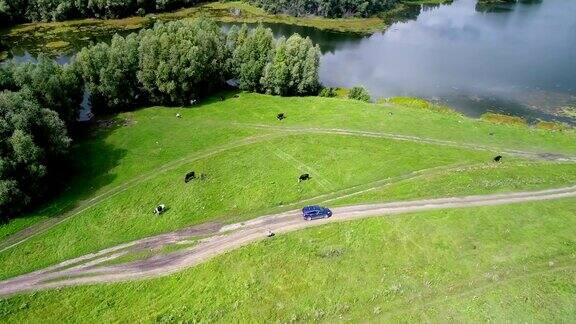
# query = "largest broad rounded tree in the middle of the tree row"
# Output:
<box><xmin>138</xmin><ymin>19</ymin><xmax>228</xmax><ymax>104</ymax></box>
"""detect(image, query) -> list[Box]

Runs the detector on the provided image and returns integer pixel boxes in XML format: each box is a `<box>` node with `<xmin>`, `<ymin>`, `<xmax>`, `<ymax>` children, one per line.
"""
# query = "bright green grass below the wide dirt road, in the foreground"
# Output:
<box><xmin>0</xmin><ymin>199</ymin><xmax>576</xmax><ymax>322</ymax></box>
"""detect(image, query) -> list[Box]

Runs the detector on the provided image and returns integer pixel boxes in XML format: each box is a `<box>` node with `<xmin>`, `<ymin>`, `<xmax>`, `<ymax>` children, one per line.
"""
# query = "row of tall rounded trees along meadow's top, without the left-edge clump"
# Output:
<box><xmin>73</xmin><ymin>19</ymin><xmax>320</xmax><ymax>109</ymax></box>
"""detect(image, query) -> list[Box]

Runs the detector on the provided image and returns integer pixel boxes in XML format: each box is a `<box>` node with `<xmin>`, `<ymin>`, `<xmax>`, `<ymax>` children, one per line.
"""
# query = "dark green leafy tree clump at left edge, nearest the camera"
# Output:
<box><xmin>0</xmin><ymin>89</ymin><xmax>70</xmax><ymax>221</ymax></box>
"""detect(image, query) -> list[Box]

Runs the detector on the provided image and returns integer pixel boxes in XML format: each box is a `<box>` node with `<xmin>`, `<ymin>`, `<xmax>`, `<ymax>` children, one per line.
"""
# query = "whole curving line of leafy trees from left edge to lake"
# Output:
<box><xmin>0</xmin><ymin>19</ymin><xmax>320</xmax><ymax>221</ymax></box>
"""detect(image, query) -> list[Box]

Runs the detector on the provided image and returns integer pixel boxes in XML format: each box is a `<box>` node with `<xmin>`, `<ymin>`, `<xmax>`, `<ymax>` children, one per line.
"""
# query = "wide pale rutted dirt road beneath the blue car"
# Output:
<box><xmin>0</xmin><ymin>186</ymin><xmax>576</xmax><ymax>297</ymax></box>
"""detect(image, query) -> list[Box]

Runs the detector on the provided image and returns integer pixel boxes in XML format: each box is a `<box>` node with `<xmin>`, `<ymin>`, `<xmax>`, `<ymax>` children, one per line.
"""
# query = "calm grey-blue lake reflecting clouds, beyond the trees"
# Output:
<box><xmin>9</xmin><ymin>0</ymin><xmax>576</xmax><ymax>123</ymax></box>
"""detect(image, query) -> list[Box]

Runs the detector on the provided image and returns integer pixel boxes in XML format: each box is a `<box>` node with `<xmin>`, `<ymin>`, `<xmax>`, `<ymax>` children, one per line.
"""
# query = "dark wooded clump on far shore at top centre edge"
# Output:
<box><xmin>249</xmin><ymin>0</ymin><xmax>398</xmax><ymax>18</ymax></box>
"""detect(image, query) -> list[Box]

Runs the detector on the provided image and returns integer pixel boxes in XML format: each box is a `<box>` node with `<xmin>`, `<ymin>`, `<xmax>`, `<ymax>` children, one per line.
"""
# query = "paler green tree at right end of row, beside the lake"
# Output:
<box><xmin>261</xmin><ymin>34</ymin><xmax>320</xmax><ymax>96</ymax></box>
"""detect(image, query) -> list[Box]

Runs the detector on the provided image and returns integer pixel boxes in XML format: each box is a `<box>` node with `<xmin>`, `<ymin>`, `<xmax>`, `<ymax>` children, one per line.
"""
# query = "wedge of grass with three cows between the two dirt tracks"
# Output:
<box><xmin>0</xmin><ymin>135</ymin><xmax>492</xmax><ymax>278</ymax></box>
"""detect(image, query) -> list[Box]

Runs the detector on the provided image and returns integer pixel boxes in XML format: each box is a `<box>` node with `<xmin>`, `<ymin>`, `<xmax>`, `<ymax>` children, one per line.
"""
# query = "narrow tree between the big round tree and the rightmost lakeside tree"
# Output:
<box><xmin>232</xmin><ymin>25</ymin><xmax>274</xmax><ymax>92</ymax></box>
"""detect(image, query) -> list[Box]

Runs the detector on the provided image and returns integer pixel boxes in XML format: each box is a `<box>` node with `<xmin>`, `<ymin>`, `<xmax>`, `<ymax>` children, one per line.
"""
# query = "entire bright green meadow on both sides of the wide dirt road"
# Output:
<box><xmin>0</xmin><ymin>93</ymin><xmax>576</xmax><ymax>321</ymax></box>
